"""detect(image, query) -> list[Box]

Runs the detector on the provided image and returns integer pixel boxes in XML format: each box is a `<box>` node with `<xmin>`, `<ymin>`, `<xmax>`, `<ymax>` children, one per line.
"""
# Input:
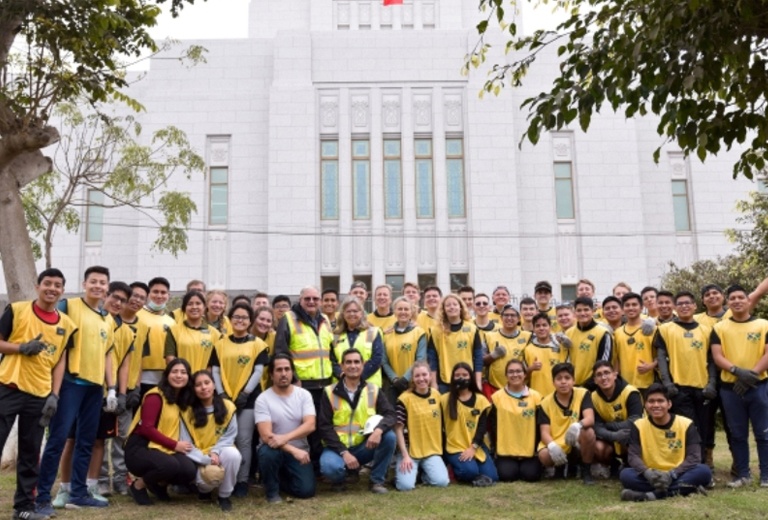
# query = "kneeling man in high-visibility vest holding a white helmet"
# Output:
<box><xmin>317</xmin><ymin>348</ymin><xmax>396</xmax><ymax>493</ymax></box>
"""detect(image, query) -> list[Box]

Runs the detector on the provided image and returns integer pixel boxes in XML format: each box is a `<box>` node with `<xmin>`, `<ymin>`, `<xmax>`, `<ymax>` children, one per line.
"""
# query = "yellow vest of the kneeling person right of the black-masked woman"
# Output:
<box><xmin>491</xmin><ymin>388</ymin><xmax>541</xmax><ymax>457</ymax></box>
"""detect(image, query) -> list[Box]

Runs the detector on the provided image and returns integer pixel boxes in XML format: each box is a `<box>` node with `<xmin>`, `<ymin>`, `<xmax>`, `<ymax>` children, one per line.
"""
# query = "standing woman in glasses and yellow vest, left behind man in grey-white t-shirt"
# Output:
<box><xmin>213</xmin><ymin>303</ymin><xmax>269</xmax><ymax>498</ymax></box>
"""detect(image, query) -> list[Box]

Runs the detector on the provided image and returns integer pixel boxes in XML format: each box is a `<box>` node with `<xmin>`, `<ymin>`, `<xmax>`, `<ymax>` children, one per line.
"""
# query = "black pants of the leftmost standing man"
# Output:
<box><xmin>0</xmin><ymin>385</ymin><xmax>45</xmax><ymax>511</ymax></box>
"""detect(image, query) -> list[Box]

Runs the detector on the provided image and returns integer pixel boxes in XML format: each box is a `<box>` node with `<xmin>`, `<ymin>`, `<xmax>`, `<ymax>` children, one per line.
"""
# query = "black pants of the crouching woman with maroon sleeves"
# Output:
<box><xmin>125</xmin><ymin>435</ymin><xmax>197</xmax><ymax>486</ymax></box>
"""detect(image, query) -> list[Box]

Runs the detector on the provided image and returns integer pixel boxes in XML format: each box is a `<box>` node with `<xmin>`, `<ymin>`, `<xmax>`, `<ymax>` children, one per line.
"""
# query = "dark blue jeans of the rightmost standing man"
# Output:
<box><xmin>720</xmin><ymin>383</ymin><xmax>768</xmax><ymax>480</ymax></box>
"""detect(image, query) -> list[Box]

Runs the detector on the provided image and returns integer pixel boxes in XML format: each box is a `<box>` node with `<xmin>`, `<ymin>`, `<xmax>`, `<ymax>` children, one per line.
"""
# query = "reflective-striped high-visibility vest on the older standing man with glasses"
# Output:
<box><xmin>285</xmin><ymin>311</ymin><xmax>333</xmax><ymax>381</ymax></box>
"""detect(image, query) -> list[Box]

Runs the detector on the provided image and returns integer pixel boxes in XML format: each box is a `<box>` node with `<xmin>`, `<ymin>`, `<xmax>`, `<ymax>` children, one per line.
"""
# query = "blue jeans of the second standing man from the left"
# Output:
<box><xmin>37</xmin><ymin>379</ymin><xmax>104</xmax><ymax>504</ymax></box>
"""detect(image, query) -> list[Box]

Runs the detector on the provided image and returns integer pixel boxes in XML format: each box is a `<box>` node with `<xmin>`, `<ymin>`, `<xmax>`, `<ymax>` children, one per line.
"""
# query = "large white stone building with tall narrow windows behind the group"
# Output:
<box><xmin>0</xmin><ymin>0</ymin><xmax>755</xmax><ymax>298</ymax></box>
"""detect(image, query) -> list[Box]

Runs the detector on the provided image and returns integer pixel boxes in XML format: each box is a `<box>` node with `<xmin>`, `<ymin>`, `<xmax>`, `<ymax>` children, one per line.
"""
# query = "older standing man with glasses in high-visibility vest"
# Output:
<box><xmin>275</xmin><ymin>287</ymin><xmax>333</xmax><ymax>465</ymax></box>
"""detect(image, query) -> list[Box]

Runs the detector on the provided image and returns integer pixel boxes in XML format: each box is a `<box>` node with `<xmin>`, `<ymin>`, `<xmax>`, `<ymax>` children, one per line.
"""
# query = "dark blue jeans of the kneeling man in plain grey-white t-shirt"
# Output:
<box><xmin>259</xmin><ymin>444</ymin><xmax>316</xmax><ymax>498</ymax></box>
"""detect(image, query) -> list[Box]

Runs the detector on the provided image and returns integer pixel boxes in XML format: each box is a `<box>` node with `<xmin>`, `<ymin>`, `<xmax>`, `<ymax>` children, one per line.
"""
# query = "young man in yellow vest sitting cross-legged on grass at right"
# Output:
<box><xmin>620</xmin><ymin>383</ymin><xmax>712</xmax><ymax>502</ymax></box>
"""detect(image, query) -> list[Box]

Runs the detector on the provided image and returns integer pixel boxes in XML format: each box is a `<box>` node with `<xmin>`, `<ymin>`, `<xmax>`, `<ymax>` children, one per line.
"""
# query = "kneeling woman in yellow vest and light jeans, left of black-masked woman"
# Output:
<box><xmin>395</xmin><ymin>362</ymin><xmax>450</xmax><ymax>491</ymax></box>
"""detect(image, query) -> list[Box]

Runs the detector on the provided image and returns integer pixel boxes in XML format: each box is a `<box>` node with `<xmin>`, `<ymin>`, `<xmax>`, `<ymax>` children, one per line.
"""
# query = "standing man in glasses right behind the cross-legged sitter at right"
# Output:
<box><xmin>654</xmin><ymin>291</ymin><xmax>717</xmax><ymax>468</ymax></box>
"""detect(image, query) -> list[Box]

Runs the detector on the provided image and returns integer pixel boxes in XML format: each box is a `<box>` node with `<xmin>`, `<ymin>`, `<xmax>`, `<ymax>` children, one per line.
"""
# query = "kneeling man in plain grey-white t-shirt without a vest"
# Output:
<box><xmin>254</xmin><ymin>354</ymin><xmax>317</xmax><ymax>504</ymax></box>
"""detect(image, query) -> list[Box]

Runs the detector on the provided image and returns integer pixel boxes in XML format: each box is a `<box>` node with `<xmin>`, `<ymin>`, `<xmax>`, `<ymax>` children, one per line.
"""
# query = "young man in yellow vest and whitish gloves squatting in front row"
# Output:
<box><xmin>537</xmin><ymin>363</ymin><xmax>595</xmax><ymax>485</ymax></box>
